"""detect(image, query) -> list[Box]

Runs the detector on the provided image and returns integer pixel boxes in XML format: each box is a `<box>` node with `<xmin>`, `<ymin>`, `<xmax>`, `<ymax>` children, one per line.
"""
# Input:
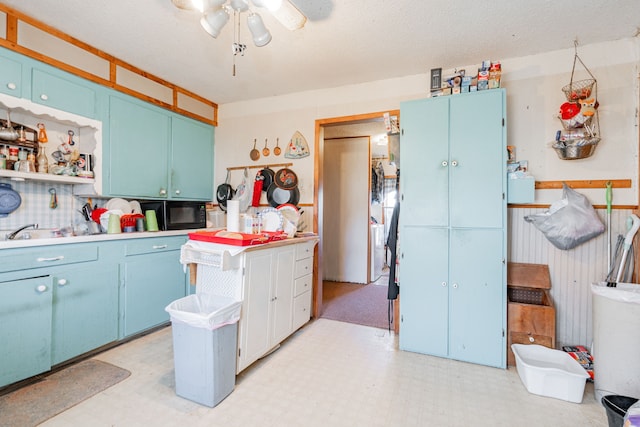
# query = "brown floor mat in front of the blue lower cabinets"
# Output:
<box><xmin>0</xmin><ymin>359</ymin><xmax>131</xmax><ymax>427</ymax></box>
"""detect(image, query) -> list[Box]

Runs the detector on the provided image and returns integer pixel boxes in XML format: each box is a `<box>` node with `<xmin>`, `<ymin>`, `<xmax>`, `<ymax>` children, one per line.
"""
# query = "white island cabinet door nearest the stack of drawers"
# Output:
<box><xmin>271</xmin><ymin>245</ymin><xmax>295</xmax><ymax>346</ymax></box>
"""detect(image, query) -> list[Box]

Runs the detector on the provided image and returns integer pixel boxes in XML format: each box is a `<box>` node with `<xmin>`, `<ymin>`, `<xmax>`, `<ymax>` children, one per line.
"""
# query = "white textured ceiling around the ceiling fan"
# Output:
<box><xmin>3</xmin><ymin>0</ymin><xmax>640</xmax><ymax>104</ymax></box>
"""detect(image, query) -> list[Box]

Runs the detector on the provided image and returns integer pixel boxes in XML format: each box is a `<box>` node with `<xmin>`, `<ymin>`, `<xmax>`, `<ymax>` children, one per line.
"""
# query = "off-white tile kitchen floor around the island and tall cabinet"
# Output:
<box><xmin>42</xmin><ymin>319</ymin><xmax>607</xmax><ymax>427</ymax></box>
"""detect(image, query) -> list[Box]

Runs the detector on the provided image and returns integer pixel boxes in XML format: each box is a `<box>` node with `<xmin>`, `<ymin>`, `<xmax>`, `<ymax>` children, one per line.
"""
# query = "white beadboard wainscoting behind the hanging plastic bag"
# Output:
<box><xmin>508</xmin><ymin>208</ymin><xmax>640</xmax><ymax>348</ymax></box>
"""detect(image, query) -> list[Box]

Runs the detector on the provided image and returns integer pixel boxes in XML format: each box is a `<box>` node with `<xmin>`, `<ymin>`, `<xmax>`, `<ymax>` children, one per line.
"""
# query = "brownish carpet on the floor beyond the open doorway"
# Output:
<box><xmin>320</xmin><ymin>281</ymin><xmax>389</xmax><ymax>329</ymax></box>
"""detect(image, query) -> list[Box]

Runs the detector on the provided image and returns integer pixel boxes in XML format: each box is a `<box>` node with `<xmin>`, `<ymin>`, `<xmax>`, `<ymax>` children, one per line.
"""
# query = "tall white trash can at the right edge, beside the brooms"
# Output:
<box><xmin>591</xmin><ymin>282</ymin><xmax>640</xmax><ymax>402</ymax></box>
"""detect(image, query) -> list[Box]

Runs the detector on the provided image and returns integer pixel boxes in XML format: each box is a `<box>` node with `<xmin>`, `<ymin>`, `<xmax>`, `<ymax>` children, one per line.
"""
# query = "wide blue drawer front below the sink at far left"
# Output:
<box><xmin>0</xmin><ymin>245</ymin><xmax>98</xmax><ymax>272</ymax></box>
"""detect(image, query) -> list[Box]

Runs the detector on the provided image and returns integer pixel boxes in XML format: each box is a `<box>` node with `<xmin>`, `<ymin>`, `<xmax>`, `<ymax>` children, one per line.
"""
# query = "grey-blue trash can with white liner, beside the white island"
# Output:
<box><xmin>165</xmin><ymin>294</ymin><xmax>241</xmax><ymax>407</ymax></box>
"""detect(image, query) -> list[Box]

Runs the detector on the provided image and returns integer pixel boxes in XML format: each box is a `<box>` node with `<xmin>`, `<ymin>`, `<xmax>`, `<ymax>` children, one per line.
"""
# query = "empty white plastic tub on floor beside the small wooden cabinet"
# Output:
<box><xmin>511</xmin><ymin>344</ymin><xmax>589</xmax><ymax>403</ymax></box>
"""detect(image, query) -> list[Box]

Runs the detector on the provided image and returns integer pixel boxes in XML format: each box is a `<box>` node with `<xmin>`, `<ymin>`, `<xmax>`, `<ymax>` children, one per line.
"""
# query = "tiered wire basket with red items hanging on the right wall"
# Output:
<box><xmin>552</xmin><ymin>41</ymin><xmax>600</xmax><ymax>160</ymax></box>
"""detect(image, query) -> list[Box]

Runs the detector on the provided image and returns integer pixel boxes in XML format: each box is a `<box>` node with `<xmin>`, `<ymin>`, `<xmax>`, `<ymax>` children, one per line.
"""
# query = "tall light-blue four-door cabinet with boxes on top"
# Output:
<box><xmin>399</xmin><ymin>89</ymin><xmax>507</xmax><ymax>368</ymax></box>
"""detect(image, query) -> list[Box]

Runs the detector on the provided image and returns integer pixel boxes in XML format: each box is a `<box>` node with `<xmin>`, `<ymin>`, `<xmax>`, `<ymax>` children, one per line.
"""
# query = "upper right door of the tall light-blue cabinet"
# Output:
<box><xmin>450</xmin><ymin>90</ymin><xmax>506</xmax><ymax>228</ymax></box>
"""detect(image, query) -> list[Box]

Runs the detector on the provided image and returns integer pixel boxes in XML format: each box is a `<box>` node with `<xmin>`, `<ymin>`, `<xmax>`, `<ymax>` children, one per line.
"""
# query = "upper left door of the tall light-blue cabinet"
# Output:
<box><xmin>400</xmin><ymin>97</ymin><xmax>449</xmax><ymax>226</ymax></box>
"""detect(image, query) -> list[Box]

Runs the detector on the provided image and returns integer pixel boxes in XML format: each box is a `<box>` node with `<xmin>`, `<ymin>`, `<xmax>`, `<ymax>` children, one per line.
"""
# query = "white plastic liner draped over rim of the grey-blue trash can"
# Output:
<box><xmin>165</xmin><ymin>294</ymin><xmax>242</xmax><ymax>330</ymax></box>
